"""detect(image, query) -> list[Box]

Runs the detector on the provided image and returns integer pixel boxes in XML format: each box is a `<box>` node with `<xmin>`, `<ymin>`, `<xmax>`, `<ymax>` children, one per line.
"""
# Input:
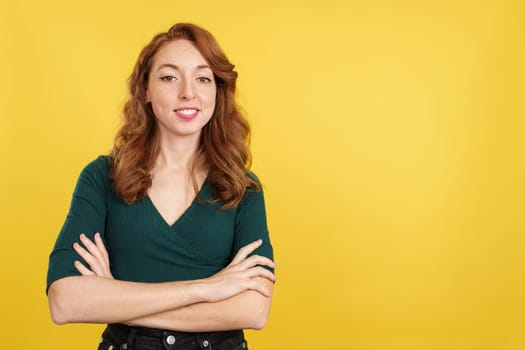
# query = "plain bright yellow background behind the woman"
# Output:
<box><xmin>0</xmin><ymin>0</ymin><xmax>525</xmax><ymax>350</ymax></box>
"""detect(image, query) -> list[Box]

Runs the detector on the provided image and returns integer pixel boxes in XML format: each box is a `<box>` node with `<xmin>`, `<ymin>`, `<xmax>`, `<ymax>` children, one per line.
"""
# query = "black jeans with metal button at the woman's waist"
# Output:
<box><xmin>98</xmin><ymin>323</ymin><xmax>248</xmax><ymax>350</ymax></box>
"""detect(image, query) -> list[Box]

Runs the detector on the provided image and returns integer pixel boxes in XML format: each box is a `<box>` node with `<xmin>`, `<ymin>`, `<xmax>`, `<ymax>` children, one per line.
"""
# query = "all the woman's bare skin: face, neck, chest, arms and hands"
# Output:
<box><xmin>48</xmin><ymin>40</ymin><xmax>276</xmax><ymax>332</ymax></box>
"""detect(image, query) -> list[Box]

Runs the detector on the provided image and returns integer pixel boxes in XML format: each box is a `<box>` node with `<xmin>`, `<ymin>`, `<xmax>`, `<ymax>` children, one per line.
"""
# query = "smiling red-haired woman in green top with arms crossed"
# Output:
<box><xmin>47</xmin><ymin>24</ymin><xmax>276</xmax><ymax>349</ymax></box>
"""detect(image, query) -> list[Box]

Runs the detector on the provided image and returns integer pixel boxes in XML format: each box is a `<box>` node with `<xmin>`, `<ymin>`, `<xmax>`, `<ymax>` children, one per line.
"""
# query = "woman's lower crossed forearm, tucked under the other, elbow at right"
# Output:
<box><xmin>125</xmin><ymin>278</ymin><xmax>273</xmax><ymax>332</ymax></box>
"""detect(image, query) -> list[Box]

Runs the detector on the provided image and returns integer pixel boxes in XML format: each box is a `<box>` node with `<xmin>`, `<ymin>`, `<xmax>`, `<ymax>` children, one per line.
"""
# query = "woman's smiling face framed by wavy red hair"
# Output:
<box><xmin>147</xmin><ymin>39</ymin><xmax>217</xmax><ymax>137</ymax></box>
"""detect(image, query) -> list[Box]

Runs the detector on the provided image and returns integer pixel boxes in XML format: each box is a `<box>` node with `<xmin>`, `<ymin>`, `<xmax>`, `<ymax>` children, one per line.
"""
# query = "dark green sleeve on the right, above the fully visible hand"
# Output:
<box><xmin>232</xmin><ymin>173</ymin><xmax>273</xmax><ymax>271</ymax></box>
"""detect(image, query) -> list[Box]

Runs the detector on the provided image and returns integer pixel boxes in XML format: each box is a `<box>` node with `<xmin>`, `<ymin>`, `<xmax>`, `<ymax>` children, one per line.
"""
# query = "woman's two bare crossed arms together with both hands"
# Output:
<box><xmin>48</xmin><ymin>234</ymin><xmax>276</xmax><ymax>332</ymax></box>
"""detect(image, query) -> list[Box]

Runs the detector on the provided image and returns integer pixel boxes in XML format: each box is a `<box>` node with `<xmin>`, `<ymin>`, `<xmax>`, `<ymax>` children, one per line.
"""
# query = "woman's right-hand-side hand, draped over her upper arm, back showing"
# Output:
<box><xmin>199</xmin><ymin>239</ymin><xmax>277</xmax><ymax>302</ymax></box>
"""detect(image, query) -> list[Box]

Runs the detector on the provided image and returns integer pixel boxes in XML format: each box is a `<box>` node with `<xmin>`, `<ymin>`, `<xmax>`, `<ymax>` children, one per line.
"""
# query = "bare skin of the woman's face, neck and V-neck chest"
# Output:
<box><xmin>147</xmin><ymin>40</ymin><xmax>217</xmax><ymax>225</ymax></box>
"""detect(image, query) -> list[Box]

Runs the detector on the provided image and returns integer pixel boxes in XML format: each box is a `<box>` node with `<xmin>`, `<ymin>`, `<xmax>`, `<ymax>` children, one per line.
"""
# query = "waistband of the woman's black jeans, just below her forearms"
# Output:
<box><xmin>107</xmin><ymin>323</ymin><xmax>244</xmax><ymax>339</ymax></box>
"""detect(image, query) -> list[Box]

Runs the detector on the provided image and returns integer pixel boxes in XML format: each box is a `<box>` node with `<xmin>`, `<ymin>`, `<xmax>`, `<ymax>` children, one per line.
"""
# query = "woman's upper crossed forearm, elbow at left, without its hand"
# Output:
<box><xmin>48</xmin><ymin>276</ymin><xmax>206</xmax><ymax>324</ymax></box>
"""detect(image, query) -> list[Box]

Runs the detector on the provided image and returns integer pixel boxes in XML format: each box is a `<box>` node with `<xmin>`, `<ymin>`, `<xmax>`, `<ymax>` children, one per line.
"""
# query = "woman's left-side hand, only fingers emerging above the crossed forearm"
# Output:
<box><xmin>73</xmin><ymin>232</ymin><xmax>114</xmax><ymax>279</ymax></box>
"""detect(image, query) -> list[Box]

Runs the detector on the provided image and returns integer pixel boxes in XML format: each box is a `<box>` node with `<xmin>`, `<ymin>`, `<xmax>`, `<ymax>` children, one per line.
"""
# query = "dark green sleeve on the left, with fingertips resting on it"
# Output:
<box><xmin>46</xmin><ymin>156</ymin><xmax>109</xmax><ymax>292</ymax></box>
